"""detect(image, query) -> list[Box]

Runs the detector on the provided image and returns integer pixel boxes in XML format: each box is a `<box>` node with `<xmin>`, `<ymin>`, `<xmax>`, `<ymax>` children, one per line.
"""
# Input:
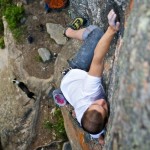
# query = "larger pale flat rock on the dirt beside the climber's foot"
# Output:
<box><xmin>46</xmin><ymin>23</ymin><xmax>66</xmax><ymax>45</ymax></box>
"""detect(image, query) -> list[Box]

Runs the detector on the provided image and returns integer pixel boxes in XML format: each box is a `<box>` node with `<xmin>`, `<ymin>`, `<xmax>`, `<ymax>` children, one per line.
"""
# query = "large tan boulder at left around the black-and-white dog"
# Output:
<box><xmin>0</xmin><ymin>18</ymin><xmax>52</xmax><ymax>150</ymax></box>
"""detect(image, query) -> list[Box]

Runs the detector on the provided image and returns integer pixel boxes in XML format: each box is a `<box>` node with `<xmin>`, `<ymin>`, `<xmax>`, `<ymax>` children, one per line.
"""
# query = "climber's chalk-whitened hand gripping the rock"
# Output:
<box><xmin>107</xmin><ymin>9</ymin><xmax>120</xmax><ymax>32</ymax></box>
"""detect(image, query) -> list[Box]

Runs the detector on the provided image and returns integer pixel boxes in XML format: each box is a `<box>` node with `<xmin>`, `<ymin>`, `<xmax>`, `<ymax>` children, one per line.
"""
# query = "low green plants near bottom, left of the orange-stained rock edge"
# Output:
<box><xmin>44</xmin><ymin>108</ymin><xmax>67</xmax><ymax>139</ymax></box>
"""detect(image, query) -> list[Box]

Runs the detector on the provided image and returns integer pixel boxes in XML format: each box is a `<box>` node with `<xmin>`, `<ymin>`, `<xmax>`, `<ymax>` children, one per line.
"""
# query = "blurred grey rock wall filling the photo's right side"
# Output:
<box><xmin>106</xmin><ymin>1</ymin><xmax>150</xmax><ymax>150</ymax></box>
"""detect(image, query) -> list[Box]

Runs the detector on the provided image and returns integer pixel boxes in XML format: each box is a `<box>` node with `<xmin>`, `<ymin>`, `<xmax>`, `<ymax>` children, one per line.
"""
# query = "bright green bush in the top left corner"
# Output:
<box><xmin>0</xmin><ymin>0</ymin><xmax>25</xmax><ymax>41</ymax></box>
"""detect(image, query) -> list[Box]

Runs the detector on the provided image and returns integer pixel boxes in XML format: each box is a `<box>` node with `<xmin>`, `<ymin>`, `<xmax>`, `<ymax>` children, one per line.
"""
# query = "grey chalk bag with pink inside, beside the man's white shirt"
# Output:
<box><xmin>53</xmin><ymin>89</ymin><xmax>67</xmax><ymax>106</ymax></box>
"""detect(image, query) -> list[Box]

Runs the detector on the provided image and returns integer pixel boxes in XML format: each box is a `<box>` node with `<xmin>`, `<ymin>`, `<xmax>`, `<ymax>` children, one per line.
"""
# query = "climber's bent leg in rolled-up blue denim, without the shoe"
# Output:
<box><xmin>66</xmin><ymin>25</ymin><xmax>104</xmax><ymax>71</ymax></box>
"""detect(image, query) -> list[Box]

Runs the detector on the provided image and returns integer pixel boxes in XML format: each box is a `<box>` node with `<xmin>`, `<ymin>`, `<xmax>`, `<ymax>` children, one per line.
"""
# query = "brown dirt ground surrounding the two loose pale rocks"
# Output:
<box><xmin>17</xmin><ymin>0</ymin><xmax>70</xmax><ymax>79</ymax></box>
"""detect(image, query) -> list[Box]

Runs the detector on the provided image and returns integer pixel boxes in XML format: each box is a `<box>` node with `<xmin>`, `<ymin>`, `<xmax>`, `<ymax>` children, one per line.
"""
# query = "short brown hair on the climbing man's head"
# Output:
<box><xmin>81</xmin><ymin>109</ymin><xmax>107</xmax><ymax>134</ymax></box>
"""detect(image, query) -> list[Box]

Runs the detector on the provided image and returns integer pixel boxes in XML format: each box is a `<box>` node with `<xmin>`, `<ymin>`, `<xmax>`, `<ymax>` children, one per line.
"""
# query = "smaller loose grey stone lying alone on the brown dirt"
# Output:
<box><xmin>38</xmin><ymin>48</ymin><xmax>52</xmax><ymax>62</ymax></box>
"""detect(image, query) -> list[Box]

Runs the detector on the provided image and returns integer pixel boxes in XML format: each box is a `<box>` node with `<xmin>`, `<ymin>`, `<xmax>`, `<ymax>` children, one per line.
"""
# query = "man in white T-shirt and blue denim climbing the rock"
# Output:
<box><xmin>55</xmin><ymin>10</ymin><xmax>120</xmax><ymax>144</ymax></box>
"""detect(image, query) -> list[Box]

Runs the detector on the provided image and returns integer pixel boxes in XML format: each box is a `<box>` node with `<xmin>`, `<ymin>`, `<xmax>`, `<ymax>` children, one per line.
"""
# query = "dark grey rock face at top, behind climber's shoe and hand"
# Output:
<box><xmin>69</xmin><ymin>0</ymin><xmax>125</xmax><ymax>29</ymax></box>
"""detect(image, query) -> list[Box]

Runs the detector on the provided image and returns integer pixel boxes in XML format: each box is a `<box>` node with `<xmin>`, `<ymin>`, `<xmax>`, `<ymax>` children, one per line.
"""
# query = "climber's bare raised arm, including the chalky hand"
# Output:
<box><xmin>89</xmin><ymin>10</ymin><xmax>120</xmax><ymax>77</ymax></box>
